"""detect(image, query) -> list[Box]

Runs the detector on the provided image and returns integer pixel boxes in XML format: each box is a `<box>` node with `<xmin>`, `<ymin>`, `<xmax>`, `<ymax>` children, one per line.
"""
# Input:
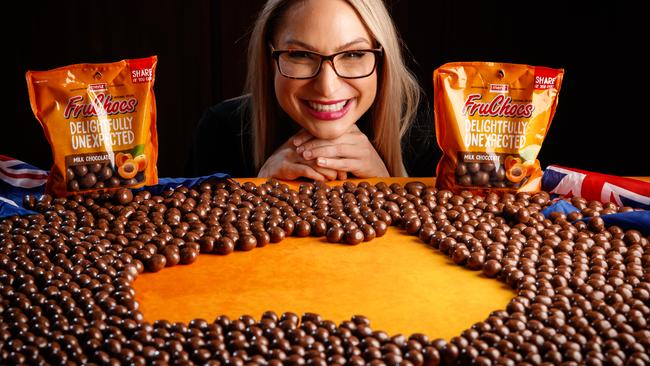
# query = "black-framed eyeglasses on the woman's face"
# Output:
<box><xmin>271</xmin><ymin>47</ymin><xmax>384</xmax><ymax>79</ymax></box>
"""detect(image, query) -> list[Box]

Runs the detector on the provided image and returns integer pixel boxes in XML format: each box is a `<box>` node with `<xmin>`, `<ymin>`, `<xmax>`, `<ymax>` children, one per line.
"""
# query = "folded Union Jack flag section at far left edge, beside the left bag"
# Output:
<box><xmin>0</xmin><ymin>155</ymin><xmax>47</xmax><ymax>218</ymax></box>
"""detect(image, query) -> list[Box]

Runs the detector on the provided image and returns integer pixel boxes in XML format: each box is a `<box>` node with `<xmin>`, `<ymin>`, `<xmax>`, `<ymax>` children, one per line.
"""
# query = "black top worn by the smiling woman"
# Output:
<box><xmin>185</xmin><ymin>96</ymin><xmax>439</xmax><ymax>177</ymax></box>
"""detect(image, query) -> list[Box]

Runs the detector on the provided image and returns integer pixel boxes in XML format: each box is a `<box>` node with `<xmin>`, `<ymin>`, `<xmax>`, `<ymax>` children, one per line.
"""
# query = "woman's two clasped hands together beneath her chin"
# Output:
<box><xmin>258</xmin><ymin>125</ymin><xmax>390</xmax><ymax>181</ymax></box>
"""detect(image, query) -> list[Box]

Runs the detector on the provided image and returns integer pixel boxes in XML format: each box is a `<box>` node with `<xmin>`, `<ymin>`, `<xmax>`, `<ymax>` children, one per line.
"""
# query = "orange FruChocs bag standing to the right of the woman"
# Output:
<box><xmin>433</xmin><ymin>62</ymin><xmax>564</xmax><ymax>193</ymax></box>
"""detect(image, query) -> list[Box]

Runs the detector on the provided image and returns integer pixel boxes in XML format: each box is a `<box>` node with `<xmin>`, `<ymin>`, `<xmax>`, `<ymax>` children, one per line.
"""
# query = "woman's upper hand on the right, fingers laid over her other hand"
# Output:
<box><xmin>294</xmin><ymin>125</ymin><xmax>390</xmax><ymax>178</ymax></box>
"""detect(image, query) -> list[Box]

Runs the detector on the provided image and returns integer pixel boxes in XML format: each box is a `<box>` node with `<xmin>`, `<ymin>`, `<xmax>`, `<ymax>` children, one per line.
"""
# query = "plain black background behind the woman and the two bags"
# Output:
<box><xmin>6</xmin><ymin>0</ymin><xmax>650</xmax><ymax>177</ymax></box>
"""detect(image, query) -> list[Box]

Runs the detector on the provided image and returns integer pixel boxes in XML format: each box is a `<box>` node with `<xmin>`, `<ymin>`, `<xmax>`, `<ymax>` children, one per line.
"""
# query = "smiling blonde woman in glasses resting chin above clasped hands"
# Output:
<box><xmin>188</xmin><ymin>0</ymin><xmax>435</xmax><ymax>180</ymax></box>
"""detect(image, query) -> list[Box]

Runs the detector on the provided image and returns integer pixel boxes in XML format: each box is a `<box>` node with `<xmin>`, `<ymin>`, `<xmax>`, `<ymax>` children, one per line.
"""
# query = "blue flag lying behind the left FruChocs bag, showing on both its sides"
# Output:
<box><xmin>0</xmin><ymin>155</ymin><xmax>230</xmax><ymax>219</ymax></box>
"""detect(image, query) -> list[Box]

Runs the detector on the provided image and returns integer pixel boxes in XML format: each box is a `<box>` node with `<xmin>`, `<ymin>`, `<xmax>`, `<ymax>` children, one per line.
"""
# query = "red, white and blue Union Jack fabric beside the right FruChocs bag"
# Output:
<box><xmin>542</xmin><ymin>165</ymin><xmax>650</xmax><ymax>210</ymax></box>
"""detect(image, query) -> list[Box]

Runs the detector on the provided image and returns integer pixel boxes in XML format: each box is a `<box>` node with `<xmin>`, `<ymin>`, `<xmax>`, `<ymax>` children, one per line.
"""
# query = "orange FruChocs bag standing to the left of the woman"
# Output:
<box><xmin>26</xmin><ymin>56</ymin><xmax>158</xmax><ymax>196</ymax></box>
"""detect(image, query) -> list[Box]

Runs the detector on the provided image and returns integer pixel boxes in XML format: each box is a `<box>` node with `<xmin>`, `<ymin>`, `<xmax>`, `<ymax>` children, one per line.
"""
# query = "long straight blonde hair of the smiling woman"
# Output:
<box><xmin>246</xmin><ymin>0</ymin><xmax>421</xmax><ymax>176</ymax></box>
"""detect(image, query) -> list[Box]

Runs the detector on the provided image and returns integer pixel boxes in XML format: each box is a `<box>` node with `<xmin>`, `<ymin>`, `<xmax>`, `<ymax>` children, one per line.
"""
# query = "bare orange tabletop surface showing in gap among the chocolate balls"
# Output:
<box><xmin>134</xmin><ymin>178</ymin><xmax>515</xmax><ymax>339</ymax></box>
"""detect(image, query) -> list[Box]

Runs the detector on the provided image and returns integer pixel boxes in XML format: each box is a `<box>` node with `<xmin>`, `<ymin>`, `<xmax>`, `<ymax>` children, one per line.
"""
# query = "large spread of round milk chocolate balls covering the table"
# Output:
<box><xmin>0</xmin><ymin>180</ymin><xmax>650</xmax><ymax>365</ymax></box>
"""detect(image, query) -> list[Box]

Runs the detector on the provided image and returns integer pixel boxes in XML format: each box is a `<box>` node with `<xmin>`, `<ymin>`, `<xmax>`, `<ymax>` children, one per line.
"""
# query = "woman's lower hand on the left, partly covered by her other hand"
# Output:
<box><xmin>257</xmin><ymin>130</ymin><xmax>347</xmax><ymax>181</ymax></box>
